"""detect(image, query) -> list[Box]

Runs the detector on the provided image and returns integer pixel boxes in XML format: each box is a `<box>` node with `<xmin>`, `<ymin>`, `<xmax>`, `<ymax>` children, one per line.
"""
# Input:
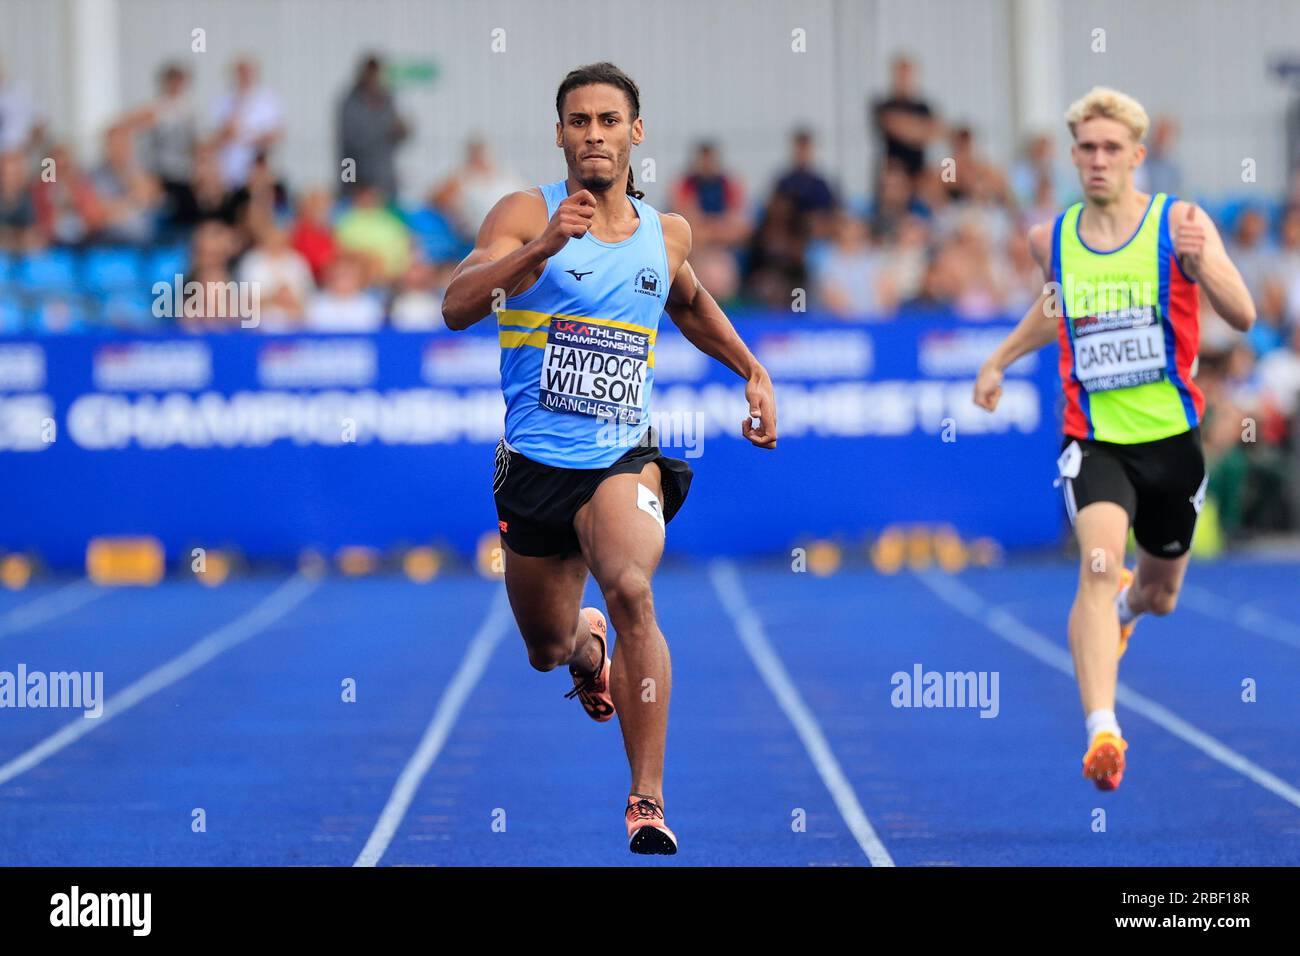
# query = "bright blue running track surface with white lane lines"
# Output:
<box><xmin>0</xmin><ymin>558</ymin><xmax>1300</xmax><ymax>866</ymax></box>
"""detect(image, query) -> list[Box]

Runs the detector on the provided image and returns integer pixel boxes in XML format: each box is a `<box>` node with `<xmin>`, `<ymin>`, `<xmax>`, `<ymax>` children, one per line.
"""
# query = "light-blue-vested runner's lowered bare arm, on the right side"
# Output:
<box><xmin>660</xmin><ymin>215</ymin><xmax>776</xmax><ymax>449</ymax></box>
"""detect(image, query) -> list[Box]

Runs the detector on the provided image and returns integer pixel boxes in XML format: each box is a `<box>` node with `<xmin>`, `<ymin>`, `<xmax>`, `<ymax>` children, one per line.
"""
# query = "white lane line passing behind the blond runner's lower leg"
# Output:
<box><xmin>917</xmin><ymin>572</ymin><xmax>1300</xmax><ymax>808</ymax></box>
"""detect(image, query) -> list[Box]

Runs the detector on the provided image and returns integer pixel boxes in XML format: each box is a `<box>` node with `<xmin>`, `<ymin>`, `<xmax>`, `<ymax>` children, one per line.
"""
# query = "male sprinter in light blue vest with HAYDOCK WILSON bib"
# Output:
<box><xmin>442</xmin><ymin>62</ymin><xmax>776</xmax><ymax>853</ymax></box>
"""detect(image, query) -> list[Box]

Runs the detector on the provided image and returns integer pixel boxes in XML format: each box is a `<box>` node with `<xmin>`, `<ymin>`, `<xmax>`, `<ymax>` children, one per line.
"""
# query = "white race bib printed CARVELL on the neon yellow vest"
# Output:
<box><xmin>1074</xmin><ymin>306</ymin><xmax>1165</xmax><ymax>392</ymax></box>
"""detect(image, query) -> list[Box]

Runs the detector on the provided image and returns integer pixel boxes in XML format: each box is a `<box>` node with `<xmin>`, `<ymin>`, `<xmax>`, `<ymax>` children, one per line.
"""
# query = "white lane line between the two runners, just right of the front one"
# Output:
<box><xmin>709</xmin><ymin>559</ymin><xmax>894</xmax><ymax>866</ymax></box>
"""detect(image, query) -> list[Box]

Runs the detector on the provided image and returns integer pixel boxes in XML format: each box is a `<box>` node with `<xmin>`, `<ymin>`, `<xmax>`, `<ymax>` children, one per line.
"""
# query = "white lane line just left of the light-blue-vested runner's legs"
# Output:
<box><xmin>352</xmin><ymin>587</ymin><xmax>511</xmax><ymax>866</ymax></box>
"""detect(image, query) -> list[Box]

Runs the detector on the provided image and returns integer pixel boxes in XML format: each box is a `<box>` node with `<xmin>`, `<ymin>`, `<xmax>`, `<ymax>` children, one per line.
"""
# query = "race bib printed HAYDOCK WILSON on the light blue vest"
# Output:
<box><xmin>538</xmin><ymin>317</ymin><xmax>650</xmax><ymax>425</ymax></box>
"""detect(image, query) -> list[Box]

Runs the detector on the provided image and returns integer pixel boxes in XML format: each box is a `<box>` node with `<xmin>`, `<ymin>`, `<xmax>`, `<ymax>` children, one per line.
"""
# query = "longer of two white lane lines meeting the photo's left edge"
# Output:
<box><xmin>0</xmin><ymin>575</ymin><xmax>320</xmax><ymax>786</ymax></box>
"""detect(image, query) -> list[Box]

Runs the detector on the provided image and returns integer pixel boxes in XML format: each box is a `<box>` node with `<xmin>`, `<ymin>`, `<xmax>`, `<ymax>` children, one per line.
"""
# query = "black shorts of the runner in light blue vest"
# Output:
<box><xmin>493</xmin><ymin>428</ymin><xmax>694</xmax><ymax>558</ymax></box>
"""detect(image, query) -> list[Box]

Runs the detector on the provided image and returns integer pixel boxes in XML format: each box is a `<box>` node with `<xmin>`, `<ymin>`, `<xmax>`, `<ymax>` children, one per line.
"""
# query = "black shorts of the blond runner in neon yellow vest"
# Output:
<box><xmin>1057</xmin><ymin>428</ymin><xmax>1208</xmax><ymax>558</ymax></box>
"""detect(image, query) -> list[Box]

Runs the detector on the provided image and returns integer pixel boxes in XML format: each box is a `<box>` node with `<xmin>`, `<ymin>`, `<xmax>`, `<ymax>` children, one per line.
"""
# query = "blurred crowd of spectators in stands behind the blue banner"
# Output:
<box><xmin>0</xmin><ymin>56</ymin><xmax>1300</xmax><ymax>533</ymax></box>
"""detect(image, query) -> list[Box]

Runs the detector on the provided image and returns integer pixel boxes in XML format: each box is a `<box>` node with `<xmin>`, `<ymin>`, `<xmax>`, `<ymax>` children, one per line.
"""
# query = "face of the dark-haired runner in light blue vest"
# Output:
<box><xmin>555</xmin><ymin>83</ymin><xmax>642</xmax><ymax>191</ymax></box>
